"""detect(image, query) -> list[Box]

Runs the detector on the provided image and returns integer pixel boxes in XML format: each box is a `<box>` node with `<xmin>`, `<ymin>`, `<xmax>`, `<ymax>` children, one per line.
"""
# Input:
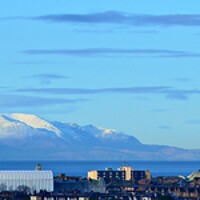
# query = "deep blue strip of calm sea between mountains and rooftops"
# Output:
<box><xmin>0</xmin><ymin>161</ymin><xmax>200</xmax><ymax>177</ymax></box>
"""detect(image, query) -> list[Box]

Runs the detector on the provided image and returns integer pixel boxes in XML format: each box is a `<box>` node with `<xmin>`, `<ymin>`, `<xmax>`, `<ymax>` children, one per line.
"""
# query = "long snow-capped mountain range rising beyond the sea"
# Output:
<box><xmin>0</xmin><ymin>113</ymin><xmax>200</xmax><ymax>160</ymax></box>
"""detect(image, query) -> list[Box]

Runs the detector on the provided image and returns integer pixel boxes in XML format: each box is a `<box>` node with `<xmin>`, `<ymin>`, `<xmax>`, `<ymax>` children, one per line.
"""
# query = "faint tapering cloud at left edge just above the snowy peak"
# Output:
<box><xmin>0</xmin><ymin>95</ymin><xmax>86</xmax><ymax>108</ymax></box>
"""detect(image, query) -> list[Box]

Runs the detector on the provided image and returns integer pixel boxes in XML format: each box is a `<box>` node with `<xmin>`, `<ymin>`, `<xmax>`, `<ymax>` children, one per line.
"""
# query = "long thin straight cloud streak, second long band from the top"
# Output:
<box><xmin>22</xmin><ymin>48</ymin><xmax>200</xmax><ymax>57</ymax></box>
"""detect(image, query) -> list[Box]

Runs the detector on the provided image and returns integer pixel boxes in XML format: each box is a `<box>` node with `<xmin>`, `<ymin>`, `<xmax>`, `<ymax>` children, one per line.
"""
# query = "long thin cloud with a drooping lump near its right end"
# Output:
<box><xmin>16</xmin><ymin>86</ymin><xmax>200</xmax><ymax>100</ymax></box>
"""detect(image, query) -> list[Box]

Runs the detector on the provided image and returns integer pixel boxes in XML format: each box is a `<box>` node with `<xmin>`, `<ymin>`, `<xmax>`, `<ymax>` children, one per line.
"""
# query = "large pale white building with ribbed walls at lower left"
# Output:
<box><xmin>0</xmin><ymin>171</ymin><xmax>54</xmax><ymax>192</ymax></box>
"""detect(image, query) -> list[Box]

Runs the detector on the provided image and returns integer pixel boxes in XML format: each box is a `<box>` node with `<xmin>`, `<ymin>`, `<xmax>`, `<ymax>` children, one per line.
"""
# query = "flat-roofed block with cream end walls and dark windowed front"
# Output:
<box><xmin>88</xmin><ymin>166</ymin><xmax>151</xmax><ymax>181</ymax></box>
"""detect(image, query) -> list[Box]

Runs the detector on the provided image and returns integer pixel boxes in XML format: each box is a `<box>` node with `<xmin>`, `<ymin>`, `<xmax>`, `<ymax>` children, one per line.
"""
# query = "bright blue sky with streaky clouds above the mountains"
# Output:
<box><xmin>0</xmin><ymin>0</ymin><xmax>200</xmax><ymax>149</ymax></box>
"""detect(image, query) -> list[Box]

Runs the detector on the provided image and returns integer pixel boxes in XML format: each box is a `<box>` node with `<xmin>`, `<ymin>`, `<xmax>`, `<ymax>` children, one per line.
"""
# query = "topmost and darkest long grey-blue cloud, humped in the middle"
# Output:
<box><xmin>29</xmin><ymin>11</ymin><xmax>200</xmax><ymax>27</ymax></box>
